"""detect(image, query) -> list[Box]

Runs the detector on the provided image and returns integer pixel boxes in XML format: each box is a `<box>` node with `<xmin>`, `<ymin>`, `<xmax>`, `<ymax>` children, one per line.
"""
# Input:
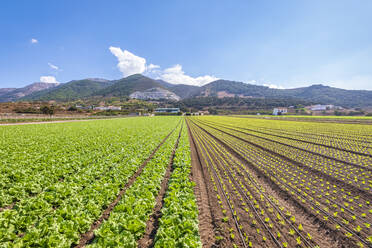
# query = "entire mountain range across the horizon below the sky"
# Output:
<box><xmin>0</xmin><ymin>74</ymin><xmax>372</xmax><ymax>107</ymax></box>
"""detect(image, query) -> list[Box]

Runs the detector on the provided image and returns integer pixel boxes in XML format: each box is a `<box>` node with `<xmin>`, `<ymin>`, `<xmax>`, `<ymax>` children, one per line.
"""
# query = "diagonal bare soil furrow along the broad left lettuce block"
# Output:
<box><xmin>75</xmin><ymin>124</ymin><xmax>178</xmax><ymax>248</ymax></box>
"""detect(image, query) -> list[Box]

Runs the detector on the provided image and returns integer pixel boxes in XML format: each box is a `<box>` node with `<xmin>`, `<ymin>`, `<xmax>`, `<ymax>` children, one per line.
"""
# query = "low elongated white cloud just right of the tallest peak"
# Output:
<box><xmin>159</xmin><ymin>64</ymin><xmax>218</xmax><ymax>86</ymax></box>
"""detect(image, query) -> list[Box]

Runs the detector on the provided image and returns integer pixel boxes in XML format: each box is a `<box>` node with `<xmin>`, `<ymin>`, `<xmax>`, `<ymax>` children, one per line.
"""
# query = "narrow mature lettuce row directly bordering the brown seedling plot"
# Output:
<box><xmin>155</xmin><ymin>123</ymin><xmax>202</xmax><ymax>247</ymax></box>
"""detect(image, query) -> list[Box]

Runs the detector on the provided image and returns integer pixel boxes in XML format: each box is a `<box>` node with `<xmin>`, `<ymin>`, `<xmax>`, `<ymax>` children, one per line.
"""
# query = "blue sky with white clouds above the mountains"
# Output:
<box><xmin>0</xmin><ymin>0</ymin><xmax>372</xmax><ymax>90</ymax></box>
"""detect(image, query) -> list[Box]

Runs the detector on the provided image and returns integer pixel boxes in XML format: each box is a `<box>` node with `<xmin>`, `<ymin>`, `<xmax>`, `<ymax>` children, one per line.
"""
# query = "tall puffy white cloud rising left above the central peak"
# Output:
<box><xmin>109</xmin><ymin>46</ymin><xmax>146</xmax><ymax>77</ymax></box>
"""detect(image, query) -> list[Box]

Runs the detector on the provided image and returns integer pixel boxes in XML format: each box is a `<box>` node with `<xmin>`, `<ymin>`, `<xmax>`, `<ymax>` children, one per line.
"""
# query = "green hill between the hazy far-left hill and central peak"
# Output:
<box><xmin>19</xmin><ymin>79</ymin><xmax>112</xmax><ymax>101</ymax></box>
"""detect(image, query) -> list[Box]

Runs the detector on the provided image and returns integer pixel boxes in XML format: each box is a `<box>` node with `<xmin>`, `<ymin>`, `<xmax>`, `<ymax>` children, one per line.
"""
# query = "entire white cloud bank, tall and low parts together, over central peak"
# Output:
<box><xmin>109</xmin><ymin>46</ymin><xmax>218</xmax><ymax>86</ymax></box>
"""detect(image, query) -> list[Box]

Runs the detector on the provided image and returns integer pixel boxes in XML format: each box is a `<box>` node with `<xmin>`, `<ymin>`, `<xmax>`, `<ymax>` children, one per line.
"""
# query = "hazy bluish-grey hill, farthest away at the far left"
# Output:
<box><xmin>0</xmin><ymin>82</ymin><xmax>59</xmax><ymax>102</ymax></box>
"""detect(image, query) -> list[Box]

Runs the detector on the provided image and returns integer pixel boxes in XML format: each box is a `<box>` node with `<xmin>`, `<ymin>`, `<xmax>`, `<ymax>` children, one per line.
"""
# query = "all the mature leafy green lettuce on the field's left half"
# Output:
<box><xmin>0</xmin><ymin>117</ymin><xmax>201</xmax><ymax>247</ymax></box>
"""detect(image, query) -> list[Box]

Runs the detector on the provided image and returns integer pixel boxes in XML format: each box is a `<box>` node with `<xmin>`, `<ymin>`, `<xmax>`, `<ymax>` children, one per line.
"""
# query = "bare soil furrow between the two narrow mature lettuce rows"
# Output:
<box><xmin>138</xmin><ymin>124</ymin><xmax>183</xmax><ymax>247</ymax></box>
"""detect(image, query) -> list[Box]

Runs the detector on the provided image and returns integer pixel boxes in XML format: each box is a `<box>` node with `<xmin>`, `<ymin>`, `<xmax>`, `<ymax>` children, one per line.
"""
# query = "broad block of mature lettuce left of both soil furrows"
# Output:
<box><xmin>0</xmin><ymin>117</ymin><xmax>180</xmax><ymax>247</ymax></box>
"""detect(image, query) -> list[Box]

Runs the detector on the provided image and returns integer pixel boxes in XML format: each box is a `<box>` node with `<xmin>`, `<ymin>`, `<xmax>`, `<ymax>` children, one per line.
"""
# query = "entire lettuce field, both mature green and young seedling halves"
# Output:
<box><xmin>0</xmin><ymin>116</ymin><xmax>372</xmax><ymax>247</ymax></box>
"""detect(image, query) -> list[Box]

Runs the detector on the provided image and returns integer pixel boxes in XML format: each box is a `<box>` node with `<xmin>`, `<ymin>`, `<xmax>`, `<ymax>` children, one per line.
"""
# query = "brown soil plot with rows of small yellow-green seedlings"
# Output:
<box><xmin>188</xmin><ymin>117</ymin><xmax>372</xmax><ymax>247</ymax></box>
